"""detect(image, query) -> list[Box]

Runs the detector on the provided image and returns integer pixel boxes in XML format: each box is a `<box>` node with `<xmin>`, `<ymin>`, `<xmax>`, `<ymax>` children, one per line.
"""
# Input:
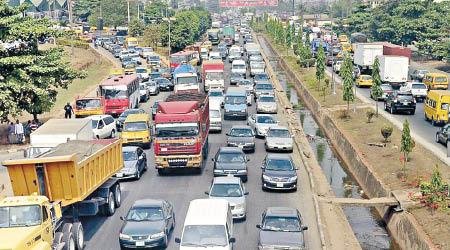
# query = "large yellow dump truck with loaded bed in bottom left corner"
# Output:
<box><xmin>0</xmin><ymin>139</ymin><xmax>123</xmax><ymax>250</ymax></box>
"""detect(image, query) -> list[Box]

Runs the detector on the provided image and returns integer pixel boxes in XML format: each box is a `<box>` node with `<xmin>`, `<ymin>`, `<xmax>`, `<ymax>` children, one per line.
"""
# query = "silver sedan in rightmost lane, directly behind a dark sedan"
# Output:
<box><xmin>264</xmin><ymin>126</ymin><xmax>294</xmax><ymax>152</ymax></box>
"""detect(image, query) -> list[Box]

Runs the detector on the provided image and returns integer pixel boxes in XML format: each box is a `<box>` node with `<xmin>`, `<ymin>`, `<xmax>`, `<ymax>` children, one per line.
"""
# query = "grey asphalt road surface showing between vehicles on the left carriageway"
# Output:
<box><xmin>82</xmin><ymin>42</ymin><xmax>320</xmax><ymax>250</ymax></box>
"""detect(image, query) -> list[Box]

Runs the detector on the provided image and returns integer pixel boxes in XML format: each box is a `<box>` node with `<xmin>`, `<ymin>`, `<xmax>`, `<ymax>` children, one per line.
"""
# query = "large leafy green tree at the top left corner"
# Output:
<box><xmin>0</xmin><ymin>0</ymin><xmax>84</xmax><ymax>122</ymax></box>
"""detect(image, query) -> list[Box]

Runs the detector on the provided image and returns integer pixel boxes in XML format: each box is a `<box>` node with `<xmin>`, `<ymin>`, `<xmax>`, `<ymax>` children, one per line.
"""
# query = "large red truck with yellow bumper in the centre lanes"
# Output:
<box><xmin>153</xmin><ymin>92</ymin><xmax>209</xmax><ymax>174</ymax></box>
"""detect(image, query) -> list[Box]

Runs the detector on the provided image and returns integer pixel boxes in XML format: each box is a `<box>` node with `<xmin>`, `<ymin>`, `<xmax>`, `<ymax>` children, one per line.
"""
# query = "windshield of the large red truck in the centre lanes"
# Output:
<box><xmin>156</xmin><ymin>122</ymin><xmax>199</xmax><ymax>137</ymax></box>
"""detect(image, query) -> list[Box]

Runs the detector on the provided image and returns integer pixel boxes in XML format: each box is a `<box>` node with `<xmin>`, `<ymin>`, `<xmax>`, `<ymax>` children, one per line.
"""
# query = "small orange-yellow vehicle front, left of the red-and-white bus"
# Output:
<box><xmin>73</xmin><ymin>96</ymin><xmax>106</xmax><ymax>118</ymax></box>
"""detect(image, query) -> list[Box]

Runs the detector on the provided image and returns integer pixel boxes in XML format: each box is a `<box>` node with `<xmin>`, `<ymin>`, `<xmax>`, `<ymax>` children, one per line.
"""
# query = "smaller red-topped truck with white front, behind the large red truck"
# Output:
<box><xmin>202</xmin><ymin>60</ymin><xmax>225</xmax><ymax>91</ymax></box>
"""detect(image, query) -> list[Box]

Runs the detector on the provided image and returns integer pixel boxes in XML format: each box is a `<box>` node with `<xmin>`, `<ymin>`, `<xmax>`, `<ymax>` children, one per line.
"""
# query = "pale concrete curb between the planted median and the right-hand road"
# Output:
<box><xmin>325</xmin><ymin>69</ymin><xmax>450</xmax><ymax>166</ymax></box>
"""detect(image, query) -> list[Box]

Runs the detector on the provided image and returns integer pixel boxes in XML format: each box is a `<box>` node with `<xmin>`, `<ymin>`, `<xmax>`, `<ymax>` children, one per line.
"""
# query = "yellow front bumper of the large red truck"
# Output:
<box><xmin>155</xmin><ymin>153</ymin><xmax>203</xmax><ymax>169</ymax></box>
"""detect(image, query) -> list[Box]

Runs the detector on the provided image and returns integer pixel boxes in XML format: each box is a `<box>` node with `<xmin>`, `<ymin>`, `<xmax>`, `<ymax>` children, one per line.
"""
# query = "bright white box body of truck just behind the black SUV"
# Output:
<box><xmin>378</xmin><ymin>55</ymin><xmax>409</xmax><ymax>86</ymax></box>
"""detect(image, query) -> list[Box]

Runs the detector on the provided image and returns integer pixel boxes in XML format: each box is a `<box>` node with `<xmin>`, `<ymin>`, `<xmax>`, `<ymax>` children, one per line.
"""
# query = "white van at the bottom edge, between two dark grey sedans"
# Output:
<box><xmin>175</xmin><ymin>199</ymin><xmax>235</xmax><ymax>250</ymax></box>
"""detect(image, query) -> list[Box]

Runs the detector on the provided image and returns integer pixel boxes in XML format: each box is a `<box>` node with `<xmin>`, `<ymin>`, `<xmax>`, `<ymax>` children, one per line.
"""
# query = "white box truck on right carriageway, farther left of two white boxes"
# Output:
<box><xmin>353</xmin><ymin>43</ymin><xmax>383</xmax><ymax>70</ymax></box>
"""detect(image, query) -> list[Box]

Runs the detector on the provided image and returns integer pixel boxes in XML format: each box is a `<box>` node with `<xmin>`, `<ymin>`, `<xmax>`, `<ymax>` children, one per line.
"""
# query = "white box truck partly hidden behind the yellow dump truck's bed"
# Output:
<box><xmin>24</xmin><ymin>119</ymin><xmax>94</xmax><ymax>158</ymax></box>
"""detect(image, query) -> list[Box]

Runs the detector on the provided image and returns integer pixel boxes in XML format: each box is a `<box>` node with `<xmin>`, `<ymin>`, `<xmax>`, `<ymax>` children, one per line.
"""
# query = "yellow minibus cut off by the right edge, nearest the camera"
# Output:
<box><xmin>424</xmin><ymin>90</ymin><xmax>450</xmax><ymax>126</ymax></box>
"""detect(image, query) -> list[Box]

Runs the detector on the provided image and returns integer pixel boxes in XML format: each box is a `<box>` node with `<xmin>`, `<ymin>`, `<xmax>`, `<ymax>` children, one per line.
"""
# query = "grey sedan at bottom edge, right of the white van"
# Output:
<box><xmin>256</xmin><ymin>207</ymin><xmax>308</xmax><ymax>249</ymax></box>
